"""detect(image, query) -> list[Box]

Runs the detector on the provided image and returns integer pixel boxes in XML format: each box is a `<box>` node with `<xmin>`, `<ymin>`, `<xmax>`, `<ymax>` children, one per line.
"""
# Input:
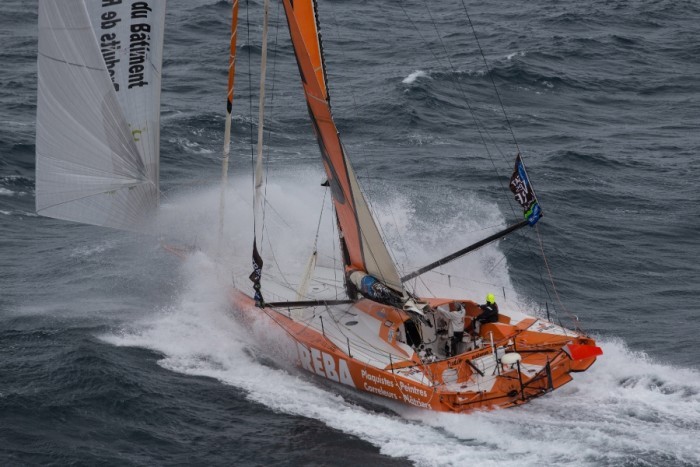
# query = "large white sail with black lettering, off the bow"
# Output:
<box><xmin>36</xmin><ymin>0</ymin><xmax>165</xmax><ymax>229</ymax></box>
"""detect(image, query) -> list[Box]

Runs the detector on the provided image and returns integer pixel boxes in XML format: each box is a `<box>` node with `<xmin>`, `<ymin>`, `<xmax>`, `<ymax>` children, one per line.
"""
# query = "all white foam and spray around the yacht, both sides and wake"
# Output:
<box><xmin>102</xmin><ymin>177</ymin><xmax>700</xmax><ymax>466</ymax></box>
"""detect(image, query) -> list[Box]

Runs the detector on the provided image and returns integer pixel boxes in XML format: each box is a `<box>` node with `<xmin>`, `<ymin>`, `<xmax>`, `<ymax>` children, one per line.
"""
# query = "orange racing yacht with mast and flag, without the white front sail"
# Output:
<box><xmin>221</xmin><ymin>0</ymin><xmax>602</xmax><ymax>412</ymax></box>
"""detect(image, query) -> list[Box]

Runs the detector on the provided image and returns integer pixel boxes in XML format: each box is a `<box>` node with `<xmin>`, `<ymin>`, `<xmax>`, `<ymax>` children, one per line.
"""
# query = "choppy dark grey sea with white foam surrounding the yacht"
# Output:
<box><xmin>0</xmin><ymin>0</ymin><xmax>700</xmax><ymax>466</ymax></box>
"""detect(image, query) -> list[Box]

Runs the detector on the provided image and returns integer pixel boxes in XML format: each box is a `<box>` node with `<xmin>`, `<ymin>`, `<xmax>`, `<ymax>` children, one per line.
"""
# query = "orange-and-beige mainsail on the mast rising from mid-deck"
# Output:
<box><xmin>284</xmin><ymin>0</ymin><xmax>404</xmax><ymax>293</ymax></box>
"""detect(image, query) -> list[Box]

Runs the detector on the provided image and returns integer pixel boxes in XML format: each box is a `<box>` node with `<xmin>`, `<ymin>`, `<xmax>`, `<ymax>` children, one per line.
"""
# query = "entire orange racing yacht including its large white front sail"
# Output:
<box><xmin>37</xmin><ymin>0</ymin><xmax>602</xmax><ymax>412</ymax></box>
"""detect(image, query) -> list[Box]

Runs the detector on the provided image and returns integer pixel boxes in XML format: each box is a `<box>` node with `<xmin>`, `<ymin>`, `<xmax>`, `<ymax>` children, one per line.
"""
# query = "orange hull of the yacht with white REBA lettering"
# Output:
<box><xmin>231</xmin><ymin>290</ymin><xmax>602</xmax><ymax>412</ymax></box>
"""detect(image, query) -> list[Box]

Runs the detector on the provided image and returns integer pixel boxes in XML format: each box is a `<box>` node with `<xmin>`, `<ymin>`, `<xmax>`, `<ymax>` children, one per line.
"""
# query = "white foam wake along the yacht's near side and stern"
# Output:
<box><xmin>103</xmin><ymin>254</ymin><xmax>700</xmax><ymax>466</ymax></box>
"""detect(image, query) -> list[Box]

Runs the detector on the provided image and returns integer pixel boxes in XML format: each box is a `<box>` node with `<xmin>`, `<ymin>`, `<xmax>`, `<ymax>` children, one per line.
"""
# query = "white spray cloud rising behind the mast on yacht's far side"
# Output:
<box><xmin>153</xmin><ymin>174</ymin><xmax>531</xmax><ymax>311</ymax></box>
